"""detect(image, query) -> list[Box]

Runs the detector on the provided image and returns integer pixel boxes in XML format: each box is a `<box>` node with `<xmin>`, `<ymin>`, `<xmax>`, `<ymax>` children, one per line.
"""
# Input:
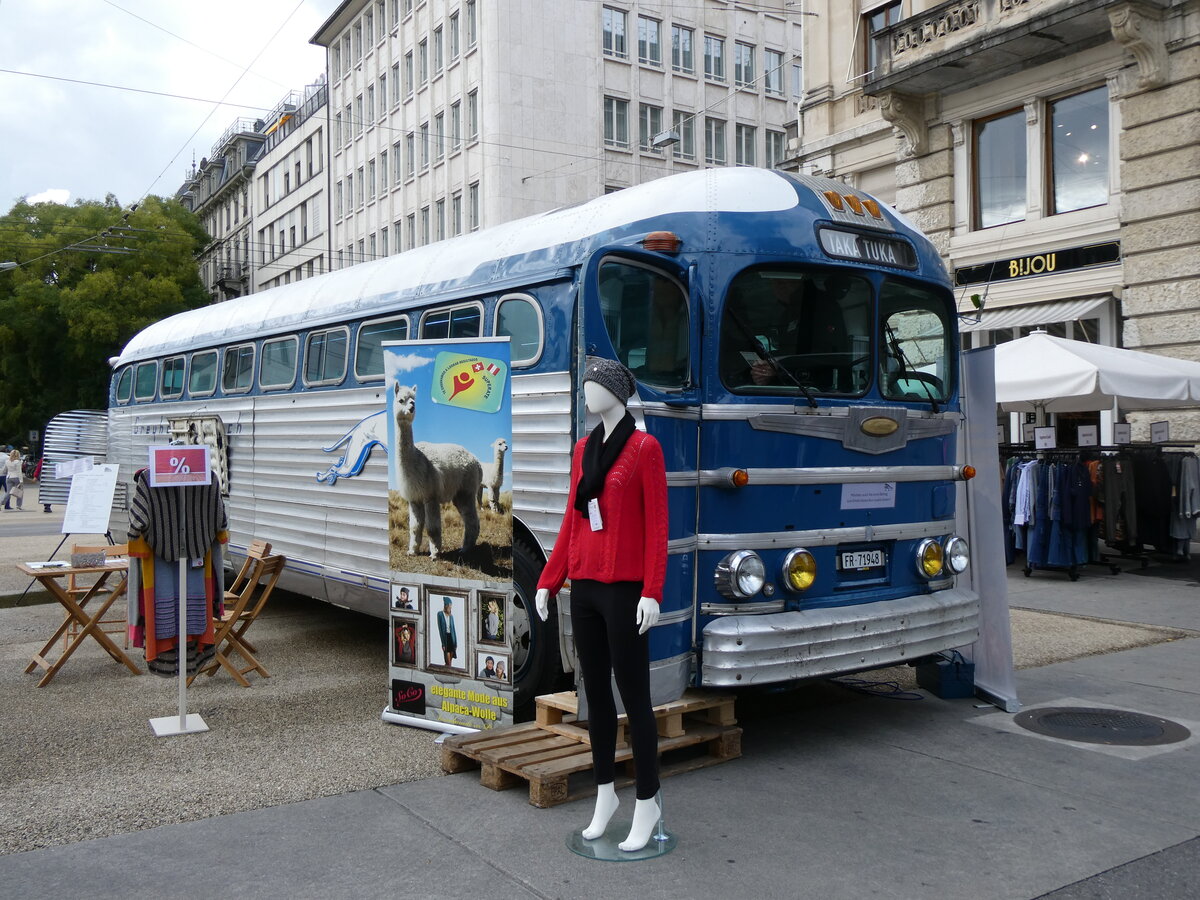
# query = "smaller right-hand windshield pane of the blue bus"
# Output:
<box><xmin>880</xmin><ymin>278</ymin><xmax>954</xmax><ymax>404</ymax></box>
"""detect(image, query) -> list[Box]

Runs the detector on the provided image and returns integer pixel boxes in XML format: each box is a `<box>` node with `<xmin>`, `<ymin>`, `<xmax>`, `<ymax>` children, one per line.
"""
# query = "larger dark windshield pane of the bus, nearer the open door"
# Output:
<box><xmin>719</xmin><ymin>266</ymin><xmax>875</xmax><ymax>397</ymax></box>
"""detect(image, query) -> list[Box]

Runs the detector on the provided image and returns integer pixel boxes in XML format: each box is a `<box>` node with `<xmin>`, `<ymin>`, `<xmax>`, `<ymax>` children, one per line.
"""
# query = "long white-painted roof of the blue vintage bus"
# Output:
<box><xmin>114</xmin><ymin>167</ymin><xmax>931</xmax><ymax>366</ymax></box>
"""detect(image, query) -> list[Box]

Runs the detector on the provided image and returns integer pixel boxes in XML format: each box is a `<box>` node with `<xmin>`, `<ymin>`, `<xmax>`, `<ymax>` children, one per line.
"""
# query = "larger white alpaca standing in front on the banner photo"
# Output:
<box><xmin>395</xmin><ymin>384</ymin><xmax>484</xmax><ymax>559</ymax></box>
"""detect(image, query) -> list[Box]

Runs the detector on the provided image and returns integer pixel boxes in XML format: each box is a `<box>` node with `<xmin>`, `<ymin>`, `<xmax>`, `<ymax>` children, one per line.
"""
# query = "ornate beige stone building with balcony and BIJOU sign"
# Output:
<box><xmin>797</xmin><ymin>0</ymin><xmax>1200</xmax><ymax>440</ymax></box>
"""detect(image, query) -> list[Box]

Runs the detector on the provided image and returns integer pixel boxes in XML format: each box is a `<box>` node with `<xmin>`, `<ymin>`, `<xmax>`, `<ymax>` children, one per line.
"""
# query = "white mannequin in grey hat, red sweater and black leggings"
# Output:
<box><xmin>535</xmin><ymin>358</ymin><xmax>667</xmax><ymax>852</ymax></box>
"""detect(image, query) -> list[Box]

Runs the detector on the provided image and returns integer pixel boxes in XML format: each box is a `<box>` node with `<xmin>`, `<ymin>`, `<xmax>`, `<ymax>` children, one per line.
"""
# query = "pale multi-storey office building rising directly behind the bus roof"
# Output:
<box><xmin>312</xmin><ymin>0</ymin><xmax>799</xmax><ymax>268</ymax></box>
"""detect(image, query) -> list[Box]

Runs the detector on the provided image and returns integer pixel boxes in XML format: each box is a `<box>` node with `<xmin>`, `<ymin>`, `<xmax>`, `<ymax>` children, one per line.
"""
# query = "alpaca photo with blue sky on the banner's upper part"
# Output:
<box><xmin>385</xmin><ymin>342</ymin><xmax>512</xmax><ymax>581</ymax></box>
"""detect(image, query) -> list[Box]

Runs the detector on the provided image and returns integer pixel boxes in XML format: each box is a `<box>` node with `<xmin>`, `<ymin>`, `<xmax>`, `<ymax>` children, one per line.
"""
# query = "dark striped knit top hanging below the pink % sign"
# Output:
<box><xmin>130</xmin><ymin>469</ymin><xmax>228</xmax><ymax>563</ymax></box>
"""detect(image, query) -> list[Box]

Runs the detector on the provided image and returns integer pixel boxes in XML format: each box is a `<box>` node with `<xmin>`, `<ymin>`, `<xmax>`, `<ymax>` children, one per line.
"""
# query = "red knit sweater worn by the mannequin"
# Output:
<box><xmin>538</xmin><ymin>431</ymin><xmax>667</xmax><ymax>604</ymax></box>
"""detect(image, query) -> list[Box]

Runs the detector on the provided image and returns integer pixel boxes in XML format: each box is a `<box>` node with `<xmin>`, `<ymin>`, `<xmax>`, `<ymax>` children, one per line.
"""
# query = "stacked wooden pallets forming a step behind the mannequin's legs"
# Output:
<box><xmin>442</xmin><ymin>691</ymin><xmax>742</xmax><ymax>809</ymax></box>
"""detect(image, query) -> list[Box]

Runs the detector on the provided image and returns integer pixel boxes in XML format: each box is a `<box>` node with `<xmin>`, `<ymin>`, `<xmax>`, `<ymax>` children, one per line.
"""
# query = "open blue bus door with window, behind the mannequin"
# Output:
<box><xmin>577</xmin><ymin>251</ymin><xmax>702</xmax><ymax>703</ymax></box>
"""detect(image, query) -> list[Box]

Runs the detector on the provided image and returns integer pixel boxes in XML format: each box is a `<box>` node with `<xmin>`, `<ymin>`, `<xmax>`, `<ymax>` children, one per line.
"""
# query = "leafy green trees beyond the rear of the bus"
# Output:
<box><xmin>0</xmin><ymin>194</ymin><xmax>210</xmax><ymax>445</ymax></box>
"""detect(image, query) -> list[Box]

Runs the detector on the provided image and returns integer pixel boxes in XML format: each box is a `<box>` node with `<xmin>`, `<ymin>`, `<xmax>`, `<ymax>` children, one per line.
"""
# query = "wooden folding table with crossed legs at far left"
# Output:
<box><xmin>17</xmin><ymin>559</ymin><xmax>142</xmax><ymax>688</ymax></box>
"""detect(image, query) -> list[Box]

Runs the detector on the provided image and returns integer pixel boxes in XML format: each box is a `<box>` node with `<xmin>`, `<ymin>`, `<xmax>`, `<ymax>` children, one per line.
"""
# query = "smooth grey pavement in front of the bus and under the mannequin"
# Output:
<box><xmin>0</xmin><ymin>518</ymin><xmax>1200</xmax><ymax>900</ymax></box>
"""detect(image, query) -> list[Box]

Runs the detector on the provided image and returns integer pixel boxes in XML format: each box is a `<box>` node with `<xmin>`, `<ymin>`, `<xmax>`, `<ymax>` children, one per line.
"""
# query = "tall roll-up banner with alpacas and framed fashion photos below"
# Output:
<box><xmin>383</xmin><ymin>338</ymin><xmax>521</xmax><ymax>731</ymax></box>
